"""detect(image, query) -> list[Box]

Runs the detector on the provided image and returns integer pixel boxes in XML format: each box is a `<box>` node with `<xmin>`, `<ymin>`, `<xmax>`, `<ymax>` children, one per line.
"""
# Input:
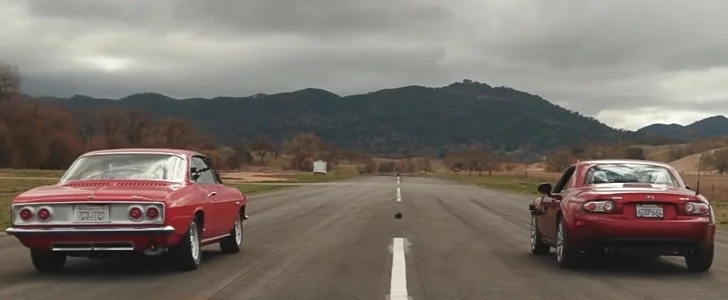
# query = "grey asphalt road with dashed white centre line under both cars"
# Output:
<box><xmin>0</xmin><ymin>177</ymin><xmax>728</xmax><ymax>300</ymax></box>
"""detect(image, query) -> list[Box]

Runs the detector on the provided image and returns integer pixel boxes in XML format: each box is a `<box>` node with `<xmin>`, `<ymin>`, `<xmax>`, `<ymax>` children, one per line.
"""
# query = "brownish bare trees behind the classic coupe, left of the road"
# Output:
<box><xmin>0</xmin><ymin>64</ymin><xmax>369</xmax><ymax>171</ymax></box>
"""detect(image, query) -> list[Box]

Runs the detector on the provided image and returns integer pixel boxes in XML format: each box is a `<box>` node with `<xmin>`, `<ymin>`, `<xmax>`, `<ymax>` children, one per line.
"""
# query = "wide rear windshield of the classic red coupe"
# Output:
<box><xmin>61</xmin><ymin>153</ymin><xmax>186</xmax><ymax>182</ymax></box>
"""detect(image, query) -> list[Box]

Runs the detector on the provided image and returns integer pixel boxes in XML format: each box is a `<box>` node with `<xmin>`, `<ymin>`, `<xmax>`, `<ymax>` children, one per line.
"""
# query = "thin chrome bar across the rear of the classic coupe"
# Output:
<box><xmin>5</xmin><ymin>225</ymin><xmax>175</xmax><ymax>236</ymax></box>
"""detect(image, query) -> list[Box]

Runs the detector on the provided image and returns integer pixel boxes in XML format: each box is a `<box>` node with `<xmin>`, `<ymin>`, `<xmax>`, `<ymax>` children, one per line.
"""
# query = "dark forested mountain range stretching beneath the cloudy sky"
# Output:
<box><xmin>31</xmin><ymin>79</ymin><xmax>728</xmax><ymax>156</ymax></box>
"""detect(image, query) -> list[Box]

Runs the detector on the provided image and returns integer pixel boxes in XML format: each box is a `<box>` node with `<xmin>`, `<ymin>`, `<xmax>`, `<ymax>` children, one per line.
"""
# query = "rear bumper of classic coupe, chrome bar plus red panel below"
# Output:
<box><xmin>7</xmin><ymin>226</ymin><xmax>181</xmax><ymax>252</ymax></box>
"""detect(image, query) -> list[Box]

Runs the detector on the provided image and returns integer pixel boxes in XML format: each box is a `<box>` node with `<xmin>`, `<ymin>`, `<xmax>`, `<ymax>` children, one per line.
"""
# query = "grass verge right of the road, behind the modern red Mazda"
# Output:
<box><xmin>435</xmin><ymin>173</ymin><xmax>728</xmax><ymax>229</ymax></box>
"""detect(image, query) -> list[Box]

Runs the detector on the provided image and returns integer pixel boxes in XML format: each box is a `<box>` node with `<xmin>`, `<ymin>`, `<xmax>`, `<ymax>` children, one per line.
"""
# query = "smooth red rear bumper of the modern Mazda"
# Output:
<box><xmin>569</xmin><ymin>216</ymin><xmax>715</xmax><ymax>255</ymax></box>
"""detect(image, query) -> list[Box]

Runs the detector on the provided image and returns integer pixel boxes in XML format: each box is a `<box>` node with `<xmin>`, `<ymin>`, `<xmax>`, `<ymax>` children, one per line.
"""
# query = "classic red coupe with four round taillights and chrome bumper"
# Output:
<box><xmin>7</xmin><ymin>149</ymin><xmax>247</xmax><ymax>272</ymax></box>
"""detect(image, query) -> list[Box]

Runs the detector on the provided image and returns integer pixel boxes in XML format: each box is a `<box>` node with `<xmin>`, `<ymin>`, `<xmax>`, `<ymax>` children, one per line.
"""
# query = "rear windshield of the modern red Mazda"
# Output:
<box><xmin>584</xmin><ymin>163</ymin><xmax>680</xmax><ymax>186</ymax></box>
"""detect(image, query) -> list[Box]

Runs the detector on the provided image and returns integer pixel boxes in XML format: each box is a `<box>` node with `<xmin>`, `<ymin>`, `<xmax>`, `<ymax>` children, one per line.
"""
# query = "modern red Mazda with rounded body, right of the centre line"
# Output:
<box><xmin>529</xmin><ymin>160</ymin><xmax>716</xmax><ymax>272</ymax></box>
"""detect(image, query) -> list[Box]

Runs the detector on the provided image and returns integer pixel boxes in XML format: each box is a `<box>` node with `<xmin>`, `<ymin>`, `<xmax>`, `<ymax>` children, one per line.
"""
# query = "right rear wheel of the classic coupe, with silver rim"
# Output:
<box><xmin>168</xmin><ymin>218</ymin><xmax>202</xmax><ymax>271</ymax></box>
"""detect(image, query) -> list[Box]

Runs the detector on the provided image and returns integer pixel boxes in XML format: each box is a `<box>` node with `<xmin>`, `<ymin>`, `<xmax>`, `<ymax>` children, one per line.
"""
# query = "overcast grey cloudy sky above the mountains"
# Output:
<box><xmin>0</xmin><ymin>0</ymin><xmax>728</xmax><ymax>129</ymax></box>
